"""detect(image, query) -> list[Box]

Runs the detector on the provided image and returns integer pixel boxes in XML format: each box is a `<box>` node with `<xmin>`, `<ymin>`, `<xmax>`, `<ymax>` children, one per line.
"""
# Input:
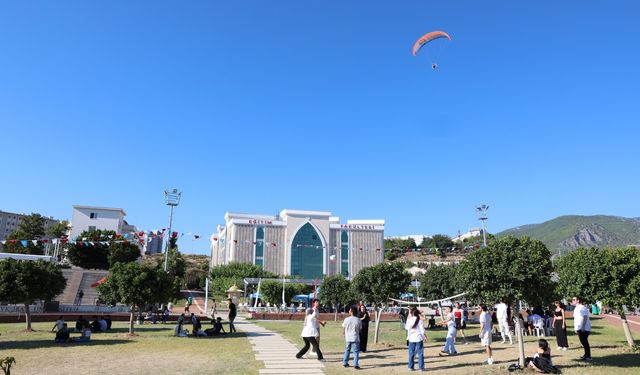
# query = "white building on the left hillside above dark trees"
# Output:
<box><xmin>69</xmin><ymin>206</ymin><xmax>127</xmax><ymax>239</ymax></box>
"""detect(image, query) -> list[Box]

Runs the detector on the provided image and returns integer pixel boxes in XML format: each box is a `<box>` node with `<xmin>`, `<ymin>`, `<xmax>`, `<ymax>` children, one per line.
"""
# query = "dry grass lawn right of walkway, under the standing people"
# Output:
<box><xmin>256</xmin><ymin>318</ymin><xmax>640</xmax><ymax>375</ymax></box>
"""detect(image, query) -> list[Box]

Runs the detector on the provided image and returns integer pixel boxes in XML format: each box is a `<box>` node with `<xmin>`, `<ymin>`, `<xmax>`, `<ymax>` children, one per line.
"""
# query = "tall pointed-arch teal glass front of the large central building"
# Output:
<box><xmin>291</xmin><ymin>223</ymin><xmax>324</xmax><ymax>279</ymax></box>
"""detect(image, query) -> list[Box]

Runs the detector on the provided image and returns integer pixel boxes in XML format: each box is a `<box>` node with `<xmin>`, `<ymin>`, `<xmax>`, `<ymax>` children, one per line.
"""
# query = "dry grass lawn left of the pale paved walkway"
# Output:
<box><xmin>0</xmin><ymin>322</ymin><xmax>261</xmax><ymax>375</ymax></box>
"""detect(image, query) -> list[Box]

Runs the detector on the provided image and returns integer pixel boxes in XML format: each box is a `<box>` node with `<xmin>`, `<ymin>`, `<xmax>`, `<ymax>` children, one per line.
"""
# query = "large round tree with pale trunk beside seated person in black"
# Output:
<box><xmin>458</xmin><ymin>237</ymin><xmax>555</xmax><ymax>366</ymax></box>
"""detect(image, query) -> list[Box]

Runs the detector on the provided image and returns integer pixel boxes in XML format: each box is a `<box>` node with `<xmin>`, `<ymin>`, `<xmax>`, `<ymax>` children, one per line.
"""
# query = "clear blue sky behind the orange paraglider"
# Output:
<box><xmin>0</xmin><ymin>0</ymin><xmax>640</xmax><ymax>253</ymax></box>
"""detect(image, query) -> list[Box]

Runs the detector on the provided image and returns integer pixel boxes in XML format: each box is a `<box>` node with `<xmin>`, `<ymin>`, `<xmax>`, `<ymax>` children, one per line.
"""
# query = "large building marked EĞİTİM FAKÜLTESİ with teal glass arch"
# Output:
<box><xmin>211</xmin><ymin>209</ymin><xmax>384</xmax><ymax>279</ymax></box>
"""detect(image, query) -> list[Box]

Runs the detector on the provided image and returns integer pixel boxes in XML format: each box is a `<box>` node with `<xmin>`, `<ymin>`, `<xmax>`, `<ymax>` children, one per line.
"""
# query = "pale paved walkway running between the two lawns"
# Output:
<box><xmin>235</xmin><ymin>317</ymin><xmax>324</xmax><ymax>374</ymax></box>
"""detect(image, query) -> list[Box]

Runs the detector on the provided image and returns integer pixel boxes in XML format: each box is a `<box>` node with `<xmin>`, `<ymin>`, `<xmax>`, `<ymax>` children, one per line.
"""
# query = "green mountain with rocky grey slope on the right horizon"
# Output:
<box><xmin>496</xmin><ymin>215</ymin><xmax>640</xmax><ymax>254</ymax></box>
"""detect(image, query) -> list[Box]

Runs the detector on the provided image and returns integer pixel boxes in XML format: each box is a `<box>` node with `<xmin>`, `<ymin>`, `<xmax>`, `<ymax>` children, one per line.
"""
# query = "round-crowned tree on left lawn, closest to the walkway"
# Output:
<box><xmin>98</xmin><ymin>262</ymin><xmax>173</xmax><ymax>334</ymax></box>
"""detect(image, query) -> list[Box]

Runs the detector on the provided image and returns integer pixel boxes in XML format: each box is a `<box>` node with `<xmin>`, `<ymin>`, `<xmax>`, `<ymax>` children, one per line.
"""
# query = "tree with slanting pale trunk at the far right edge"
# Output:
<box><xmin>556</xmin><ymin>248</ymin><xmax>640</xmax><ymax>346</ymax></box>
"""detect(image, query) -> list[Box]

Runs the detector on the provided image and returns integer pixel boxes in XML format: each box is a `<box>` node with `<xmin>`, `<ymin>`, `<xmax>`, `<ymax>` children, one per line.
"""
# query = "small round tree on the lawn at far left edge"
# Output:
<box><xmin>0</xmin><ymin>259</ymin><xmax>67</xmax><ymax>331</ymax></box>
